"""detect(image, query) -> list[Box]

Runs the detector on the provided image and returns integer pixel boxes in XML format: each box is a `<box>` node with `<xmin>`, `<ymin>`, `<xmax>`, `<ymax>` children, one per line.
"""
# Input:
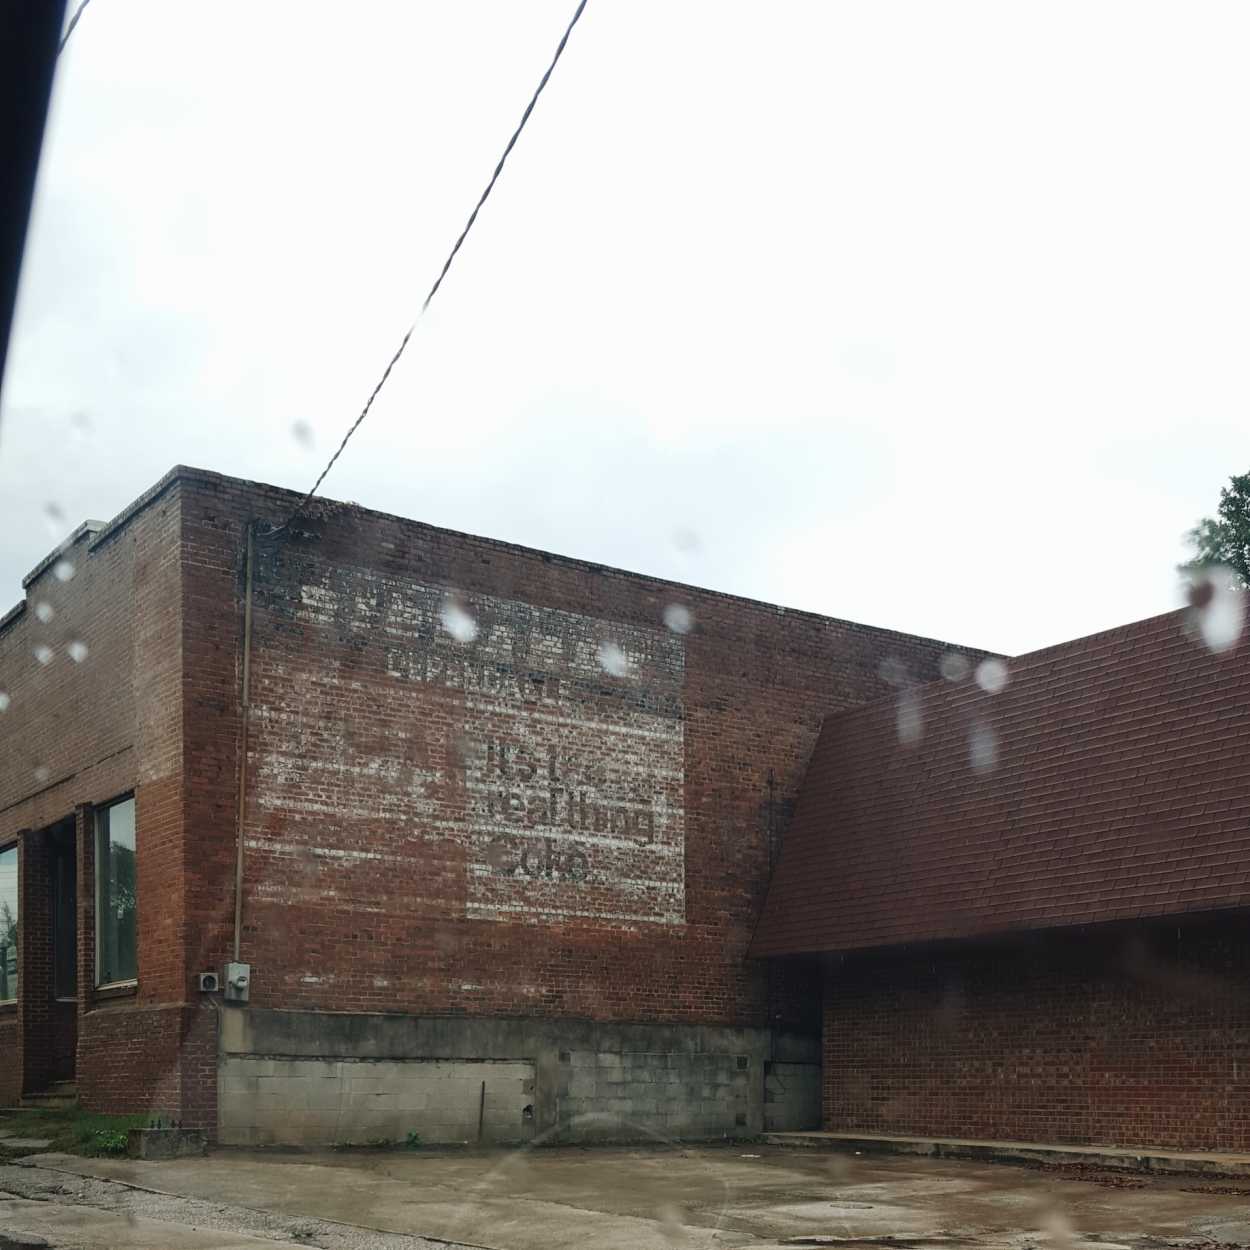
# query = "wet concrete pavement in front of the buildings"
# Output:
<box><xmin>7</xmin><ymin>1146</ymin><xmax>1250</xmax><ymax>1250</ymax></box>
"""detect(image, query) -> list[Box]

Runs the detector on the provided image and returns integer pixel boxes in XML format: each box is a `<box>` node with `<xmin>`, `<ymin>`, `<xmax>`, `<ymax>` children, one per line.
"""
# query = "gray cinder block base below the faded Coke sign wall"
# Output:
<box><xmin>218</xmin><ymin>1008</ymin><xmax>820</xmax><ymax>1146</ymax></box>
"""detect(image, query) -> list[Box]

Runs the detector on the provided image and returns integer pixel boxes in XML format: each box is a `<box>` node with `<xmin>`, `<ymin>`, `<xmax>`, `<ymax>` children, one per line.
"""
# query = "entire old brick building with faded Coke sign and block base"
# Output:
<box><xmin>0</xmin><ymin>469</ymin><xmax>965</xmax><ymax>1143</ymax></box>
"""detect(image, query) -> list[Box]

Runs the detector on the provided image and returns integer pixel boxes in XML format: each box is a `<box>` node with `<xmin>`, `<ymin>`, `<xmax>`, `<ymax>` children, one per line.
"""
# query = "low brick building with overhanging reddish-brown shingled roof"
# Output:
<box><xmin>753</xmin><ymin>605</ymin><xmax>1250</xmax><ymax>1151</ymax></box>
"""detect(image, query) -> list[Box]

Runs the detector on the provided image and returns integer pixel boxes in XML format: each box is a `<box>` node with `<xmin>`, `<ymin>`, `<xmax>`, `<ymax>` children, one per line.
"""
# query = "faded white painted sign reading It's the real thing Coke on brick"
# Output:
<box><xmin>263</xmin><ymin>570</ymin><xmax>685</xmax><ymax>925</ymax></box>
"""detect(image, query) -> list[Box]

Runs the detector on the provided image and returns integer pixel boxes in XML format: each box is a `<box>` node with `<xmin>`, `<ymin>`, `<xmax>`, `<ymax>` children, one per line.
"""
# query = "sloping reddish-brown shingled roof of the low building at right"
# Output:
<box><xmin>753</xmin><ymin>600</ymin><xmax>1250</xmax><ymax>955</ymax></box>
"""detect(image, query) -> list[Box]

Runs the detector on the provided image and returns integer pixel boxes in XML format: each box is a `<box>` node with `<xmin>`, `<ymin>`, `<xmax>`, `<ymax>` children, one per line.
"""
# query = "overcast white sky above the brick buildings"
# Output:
<box><xmin>0</xmin><ymin>0</ymin><xmax>1250</xmax><ymax>653</ymax></box>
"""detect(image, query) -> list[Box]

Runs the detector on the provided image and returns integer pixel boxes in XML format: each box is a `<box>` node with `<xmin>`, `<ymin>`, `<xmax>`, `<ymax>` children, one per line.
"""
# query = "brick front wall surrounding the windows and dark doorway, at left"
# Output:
<box><xmin>0</xmin><ymin>481</ymin><xmax>188</xmax><ymax>1110</ymax></box>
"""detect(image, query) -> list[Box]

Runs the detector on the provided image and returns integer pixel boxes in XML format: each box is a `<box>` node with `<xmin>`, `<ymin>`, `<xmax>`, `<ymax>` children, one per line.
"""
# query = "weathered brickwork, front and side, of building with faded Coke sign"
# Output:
<box><xmin>0</xmin><ymin>470</ymin><xmax>975</xmax><ymax>1129</ymax></box>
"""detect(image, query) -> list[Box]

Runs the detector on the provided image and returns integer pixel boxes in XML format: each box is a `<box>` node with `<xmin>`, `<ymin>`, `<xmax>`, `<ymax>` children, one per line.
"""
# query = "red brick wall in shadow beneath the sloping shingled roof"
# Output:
<box><xmin>823</xmin><ymin>919</ymin><xmax>1250</xmax><ymax>1151</ymax></box>
